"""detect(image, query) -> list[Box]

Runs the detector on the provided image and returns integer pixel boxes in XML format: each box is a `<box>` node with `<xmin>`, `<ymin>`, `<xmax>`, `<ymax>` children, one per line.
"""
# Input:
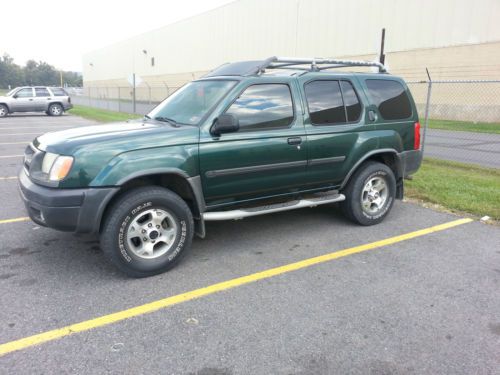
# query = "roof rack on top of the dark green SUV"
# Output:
<box><xmin>204</xmin><ymin>56</ymin><xmax>387</xmax><ymax>77</ymax></box>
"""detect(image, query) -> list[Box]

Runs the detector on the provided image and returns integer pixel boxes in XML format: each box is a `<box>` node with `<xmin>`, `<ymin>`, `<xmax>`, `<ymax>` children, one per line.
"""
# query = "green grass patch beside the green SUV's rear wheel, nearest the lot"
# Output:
<box><xmin>405</xmin><ymin>158</ymin><xmax>500</xmax><ymax>221</ymax></box>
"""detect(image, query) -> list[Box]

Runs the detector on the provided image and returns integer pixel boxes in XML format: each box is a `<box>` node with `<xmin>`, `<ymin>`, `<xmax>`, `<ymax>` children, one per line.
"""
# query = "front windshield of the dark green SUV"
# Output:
<box><xmin>148</xmin><ymin>80</ymin><xmax>236</xmax><ymax>125</ymax></box>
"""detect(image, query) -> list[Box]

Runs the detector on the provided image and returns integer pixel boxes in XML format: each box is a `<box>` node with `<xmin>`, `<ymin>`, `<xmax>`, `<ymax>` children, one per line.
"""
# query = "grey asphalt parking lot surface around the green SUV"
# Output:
<box><xmin>0</xmin><ymin>115</ymin><xmax>500</xmax><ymax>375</ymax></box>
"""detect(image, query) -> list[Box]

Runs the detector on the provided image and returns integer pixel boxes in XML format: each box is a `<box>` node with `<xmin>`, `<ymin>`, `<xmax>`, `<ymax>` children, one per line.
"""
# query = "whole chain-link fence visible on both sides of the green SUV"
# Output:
<box><xmin>68</xmin><ymin>80</ymin><xmax>500</xmax><ymax>169</ymax></box>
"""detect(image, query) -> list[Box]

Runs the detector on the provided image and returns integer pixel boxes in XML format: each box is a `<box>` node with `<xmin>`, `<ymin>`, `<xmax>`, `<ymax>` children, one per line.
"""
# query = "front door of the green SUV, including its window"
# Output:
<box><xmin>200</xmin><ymin>82</ymin><xmax>307</xmax><ymax>206</ymax></box>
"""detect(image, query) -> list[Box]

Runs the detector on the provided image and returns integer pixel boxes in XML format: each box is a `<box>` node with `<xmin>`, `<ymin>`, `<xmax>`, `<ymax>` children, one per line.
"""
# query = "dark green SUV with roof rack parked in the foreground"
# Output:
<box><xmin>19</xmin><ymin>57</ymin><xmax>422</xmax><ymax>277</ymax></box>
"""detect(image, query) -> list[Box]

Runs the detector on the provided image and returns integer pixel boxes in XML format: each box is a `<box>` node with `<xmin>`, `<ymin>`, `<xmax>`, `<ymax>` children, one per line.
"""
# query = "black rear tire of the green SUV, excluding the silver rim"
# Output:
<box><xmin>340</xmin><ymin>161</ymin><xmax>396</xmax><ymax>226</ymax></box>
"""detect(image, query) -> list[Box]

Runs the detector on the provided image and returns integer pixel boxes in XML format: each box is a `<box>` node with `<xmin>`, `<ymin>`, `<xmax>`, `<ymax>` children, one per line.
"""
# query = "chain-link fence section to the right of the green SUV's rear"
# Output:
<box><xmin>407</xmin><ymin>80</ymin><xmax>500</xmax><ymax>169</ymax></box>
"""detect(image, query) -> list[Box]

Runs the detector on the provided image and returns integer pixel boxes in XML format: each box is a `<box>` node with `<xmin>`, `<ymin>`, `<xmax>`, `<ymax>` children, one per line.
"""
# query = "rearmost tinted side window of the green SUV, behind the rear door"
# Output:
<box><xmin>366</xmin><ymin>79</ymin><xmax>411</xmax><ymax>120</ymax></box>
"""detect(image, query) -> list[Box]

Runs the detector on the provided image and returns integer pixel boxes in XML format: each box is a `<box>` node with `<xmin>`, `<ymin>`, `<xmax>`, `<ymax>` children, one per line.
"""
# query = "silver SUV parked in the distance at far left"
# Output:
<box><xmin>0</xmin><ymin>86</ymin><xmax>73</xmax><ymax>117</ymax></box>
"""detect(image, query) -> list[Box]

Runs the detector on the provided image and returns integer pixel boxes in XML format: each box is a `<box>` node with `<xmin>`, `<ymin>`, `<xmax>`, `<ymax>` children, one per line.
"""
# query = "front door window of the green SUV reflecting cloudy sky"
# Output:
<box><xmin>226</xmin><ymin>84</ymin><xmax>293</xmax><ymax>131</ymax></box>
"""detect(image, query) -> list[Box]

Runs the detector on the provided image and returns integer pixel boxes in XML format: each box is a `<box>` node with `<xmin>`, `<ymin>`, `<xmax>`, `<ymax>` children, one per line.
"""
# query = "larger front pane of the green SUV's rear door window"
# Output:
<box><xmin>305</xmin><ymin>81</ymin><xmax>346</xmax><ymax>124</ymax></box>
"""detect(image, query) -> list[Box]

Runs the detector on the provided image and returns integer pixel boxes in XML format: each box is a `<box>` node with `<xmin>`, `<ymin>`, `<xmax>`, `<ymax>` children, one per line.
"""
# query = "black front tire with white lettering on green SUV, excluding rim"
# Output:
<box><xmin>100</xmin><ymin>186</ymin><xmax>194</xmax><ymax>278</ymax></box>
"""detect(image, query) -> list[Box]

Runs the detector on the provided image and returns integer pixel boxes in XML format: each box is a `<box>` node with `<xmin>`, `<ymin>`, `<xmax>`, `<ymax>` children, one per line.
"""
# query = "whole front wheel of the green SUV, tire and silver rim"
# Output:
<box><xmin>101</xmin><ymin>186</ymin><xmax>194</xmax><ymax>277</ymax></box>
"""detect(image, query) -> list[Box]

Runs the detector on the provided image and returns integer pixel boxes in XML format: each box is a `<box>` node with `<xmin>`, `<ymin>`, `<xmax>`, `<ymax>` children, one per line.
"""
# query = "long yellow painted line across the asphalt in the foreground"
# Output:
<box><xmin>0</xmin><ymin>218</ymin><xmax>473</xmax><ymax>356</ymax></box>
